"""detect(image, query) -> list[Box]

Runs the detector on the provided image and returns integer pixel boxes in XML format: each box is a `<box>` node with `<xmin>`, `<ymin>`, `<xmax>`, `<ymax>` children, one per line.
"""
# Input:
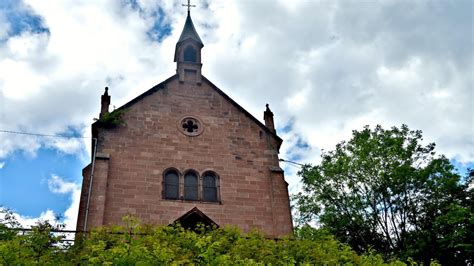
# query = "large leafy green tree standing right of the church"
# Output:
<box><xmin>295</xmin><ymin>125</ymin><xmax>474</xmax><ymax>265</ymax></box>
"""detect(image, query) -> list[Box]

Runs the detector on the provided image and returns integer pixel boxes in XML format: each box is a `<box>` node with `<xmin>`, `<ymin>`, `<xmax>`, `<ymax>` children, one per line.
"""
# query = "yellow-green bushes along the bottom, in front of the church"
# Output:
<box><xmin>0</xmin><ymin>212</ymin><xmax>403</xmax><ymax>265</ymax></box>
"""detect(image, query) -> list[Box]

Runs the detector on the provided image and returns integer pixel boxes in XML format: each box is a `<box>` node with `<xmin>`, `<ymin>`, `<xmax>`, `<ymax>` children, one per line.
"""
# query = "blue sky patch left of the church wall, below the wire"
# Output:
<box><xmin>0</xmin><ymin>148</ymin><xmax>84</xmax><ymax>217</ymax></box>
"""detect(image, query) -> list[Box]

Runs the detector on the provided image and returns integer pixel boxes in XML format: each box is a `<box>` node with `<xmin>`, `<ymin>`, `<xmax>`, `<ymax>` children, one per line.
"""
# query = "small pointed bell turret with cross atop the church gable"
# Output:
<box><xmin>174</xmin><ymin>1</ymin><xmax>204</xmax><ymax>84</ymax></box>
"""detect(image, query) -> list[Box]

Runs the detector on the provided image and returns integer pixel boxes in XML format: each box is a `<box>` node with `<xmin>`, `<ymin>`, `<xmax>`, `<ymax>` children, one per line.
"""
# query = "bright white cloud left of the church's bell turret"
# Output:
<box><xmin>0</xmin><ymin>1</ymin><xmax>173</xmax><ymax>157</ymax></box>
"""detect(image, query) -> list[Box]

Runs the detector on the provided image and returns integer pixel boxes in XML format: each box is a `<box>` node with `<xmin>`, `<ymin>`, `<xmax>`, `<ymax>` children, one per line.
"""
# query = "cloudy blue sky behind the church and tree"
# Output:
<box><xmin>0</xmin><ymin>0</ymin><xmax>474</xmax><ymax>229</ymax></box>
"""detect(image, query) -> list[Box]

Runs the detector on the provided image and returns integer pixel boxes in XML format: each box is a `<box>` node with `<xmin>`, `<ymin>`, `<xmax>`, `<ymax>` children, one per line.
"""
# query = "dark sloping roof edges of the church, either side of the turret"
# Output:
<box><xmin>92</xmin><ymin>74</ymin><xmax>283</xmax><ymax>149</ymax></box>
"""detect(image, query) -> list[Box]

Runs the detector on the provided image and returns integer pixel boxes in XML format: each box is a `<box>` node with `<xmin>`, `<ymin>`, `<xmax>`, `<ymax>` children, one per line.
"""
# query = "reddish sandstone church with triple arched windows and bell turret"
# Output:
<box><xmin>77</xmin><ymin>6</ymin><xmax>293</xmax><ymax>237</ymax></box>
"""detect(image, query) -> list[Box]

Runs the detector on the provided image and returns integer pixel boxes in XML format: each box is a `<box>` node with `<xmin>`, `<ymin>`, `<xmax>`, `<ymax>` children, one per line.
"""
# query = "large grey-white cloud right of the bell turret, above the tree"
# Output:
<box><xmin>203</xmin><ymin>1</ymin><xmax>474</xmax><ymax>162</ymax></box>
